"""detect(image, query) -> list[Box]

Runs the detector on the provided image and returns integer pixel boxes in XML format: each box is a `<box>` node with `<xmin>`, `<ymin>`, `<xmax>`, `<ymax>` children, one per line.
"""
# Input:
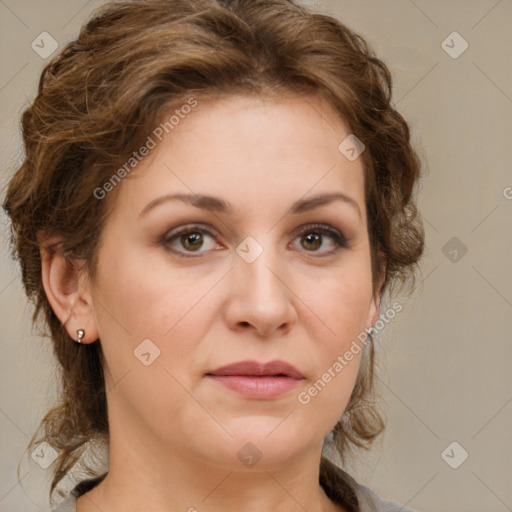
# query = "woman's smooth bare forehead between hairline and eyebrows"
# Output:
<box><xmin>109</xmin><ymin>96</ymin><xmax>364</xmax><ymax>220</ymax></box>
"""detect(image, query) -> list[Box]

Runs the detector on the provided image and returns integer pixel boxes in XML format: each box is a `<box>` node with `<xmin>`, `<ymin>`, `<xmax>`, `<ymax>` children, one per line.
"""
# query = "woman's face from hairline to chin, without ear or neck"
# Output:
<box><xmin>82</xmin><ymin>97</ymin><xmax>378</xmax><ymax>468</ymax></box>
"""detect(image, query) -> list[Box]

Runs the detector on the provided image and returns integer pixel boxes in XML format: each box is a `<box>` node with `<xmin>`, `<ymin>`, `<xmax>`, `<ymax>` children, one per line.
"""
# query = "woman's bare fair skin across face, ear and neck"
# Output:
<box><xmin>43</xmin><ymin>96</ymin><xmax>379</xmax><ymax>512</ymax></box>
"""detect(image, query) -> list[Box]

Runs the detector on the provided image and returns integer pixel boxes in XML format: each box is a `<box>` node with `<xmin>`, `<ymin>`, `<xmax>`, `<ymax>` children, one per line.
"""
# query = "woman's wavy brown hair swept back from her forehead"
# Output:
<box><xmin>3</xmin><ymin>0</ymin><xmax>424</xmax><ymax>502</ymax></box>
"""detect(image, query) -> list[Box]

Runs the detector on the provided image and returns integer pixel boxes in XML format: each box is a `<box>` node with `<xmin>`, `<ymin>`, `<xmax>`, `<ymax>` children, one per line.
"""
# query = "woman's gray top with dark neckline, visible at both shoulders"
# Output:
<box><xmin>50</xmin><ymin>457</ymin><xmax>414</xmax><ymax>512</ymax></box>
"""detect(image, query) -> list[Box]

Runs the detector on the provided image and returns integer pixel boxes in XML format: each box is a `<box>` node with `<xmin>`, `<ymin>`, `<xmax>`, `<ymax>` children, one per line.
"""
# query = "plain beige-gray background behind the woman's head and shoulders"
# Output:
<box><xmin>0</xmin><ymin>0</ymin><xmax>512</xmax><ymax>512</ymax></box>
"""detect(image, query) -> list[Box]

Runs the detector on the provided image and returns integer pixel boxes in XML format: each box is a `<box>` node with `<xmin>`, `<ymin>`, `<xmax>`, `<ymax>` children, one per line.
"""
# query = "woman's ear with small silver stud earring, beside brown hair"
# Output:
<box><xmin>41</xmin><ymin>238</ymin><xmax>99</xmax><ymax>343</ymax></box>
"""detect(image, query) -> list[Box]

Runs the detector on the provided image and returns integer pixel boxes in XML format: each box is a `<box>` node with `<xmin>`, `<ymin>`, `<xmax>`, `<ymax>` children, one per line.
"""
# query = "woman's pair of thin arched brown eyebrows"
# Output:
<box><xmin>140</xmin><ymin>192</ymin><xmax>362</xmax><ymax>219</ymax></box>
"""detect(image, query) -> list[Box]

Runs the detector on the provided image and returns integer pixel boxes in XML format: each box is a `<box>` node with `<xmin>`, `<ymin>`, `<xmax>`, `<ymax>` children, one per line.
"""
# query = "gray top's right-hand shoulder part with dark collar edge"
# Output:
<box><xmin>320</xmin><ymin>457</ymin><xmax>415</xmax><ymax>512</ymax></box>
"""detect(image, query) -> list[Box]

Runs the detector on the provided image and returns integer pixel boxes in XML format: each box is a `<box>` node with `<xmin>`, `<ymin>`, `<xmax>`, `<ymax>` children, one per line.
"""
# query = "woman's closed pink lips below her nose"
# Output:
<box><xmin>206</xmin><ymin>360</ymin><xmax>304</xmax><ymax>399</ymax></box>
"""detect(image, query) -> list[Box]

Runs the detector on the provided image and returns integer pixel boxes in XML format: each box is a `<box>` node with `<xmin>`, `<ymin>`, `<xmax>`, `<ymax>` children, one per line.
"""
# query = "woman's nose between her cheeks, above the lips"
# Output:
<box><xmin>225</xmin><ymin>243</ymin><xmax>297</xmax><ymax>337</ymax></box>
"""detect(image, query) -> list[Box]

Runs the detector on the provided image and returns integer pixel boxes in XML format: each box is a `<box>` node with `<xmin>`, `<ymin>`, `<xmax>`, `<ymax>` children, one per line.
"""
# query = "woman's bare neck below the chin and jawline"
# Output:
<box><xmin>77</xmin><ymin>428</ymin><xmax>344</xmax><ymax>512</ymax></box>
